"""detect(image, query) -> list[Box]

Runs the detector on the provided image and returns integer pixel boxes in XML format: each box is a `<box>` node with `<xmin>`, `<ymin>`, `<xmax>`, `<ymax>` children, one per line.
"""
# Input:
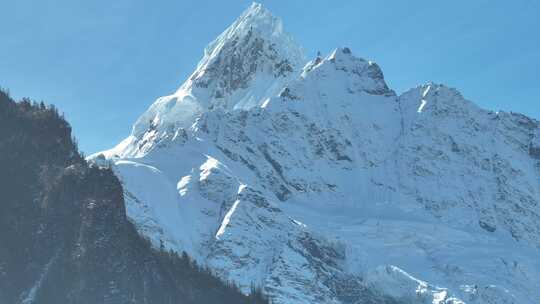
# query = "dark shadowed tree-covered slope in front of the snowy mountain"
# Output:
<box><xmin>0</xmin><ymin>91</ymin><xmax>267</xmax><ymax>304</ymax></box>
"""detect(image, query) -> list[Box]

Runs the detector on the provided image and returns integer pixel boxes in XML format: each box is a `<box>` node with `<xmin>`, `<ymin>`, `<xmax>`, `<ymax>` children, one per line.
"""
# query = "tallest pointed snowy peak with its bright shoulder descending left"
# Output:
<box><xmin>122</xmin><ymin>3</ymin><xmax>305</xmax><ymax>151</ymax></box>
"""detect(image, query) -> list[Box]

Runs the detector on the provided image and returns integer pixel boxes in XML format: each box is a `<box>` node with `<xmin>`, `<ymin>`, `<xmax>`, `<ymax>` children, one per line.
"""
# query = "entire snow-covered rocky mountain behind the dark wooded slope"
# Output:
<box><xmin>93</xmin><ymin>4</ymin><xmax>540</xmax><ymax>303</ymax></box>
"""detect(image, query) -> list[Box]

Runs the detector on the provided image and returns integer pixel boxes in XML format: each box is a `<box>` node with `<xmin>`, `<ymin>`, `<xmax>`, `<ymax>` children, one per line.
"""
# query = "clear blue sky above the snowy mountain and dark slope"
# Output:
<box><xmin>0</xmin><ymin>0</ymin><xmax>540</xmax><ymax>153</ymax></box>
